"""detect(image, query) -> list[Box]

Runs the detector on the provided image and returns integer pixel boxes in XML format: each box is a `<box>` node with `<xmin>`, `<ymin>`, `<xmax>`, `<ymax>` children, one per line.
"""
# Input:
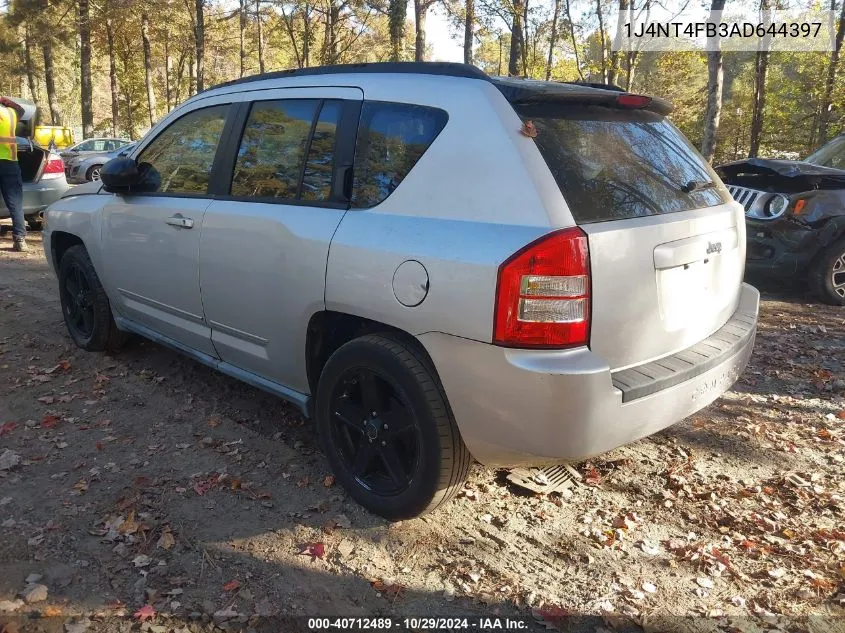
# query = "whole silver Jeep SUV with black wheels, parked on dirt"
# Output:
<box><xmin>44</xmin><ymin>63</ymin><xmax>759</xmax><ymax>519</ymax></box>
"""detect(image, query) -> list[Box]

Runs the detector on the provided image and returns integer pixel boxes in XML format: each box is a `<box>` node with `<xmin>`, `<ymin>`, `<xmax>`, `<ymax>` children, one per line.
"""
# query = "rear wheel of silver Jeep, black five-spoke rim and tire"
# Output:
<box><xmin>316</xmin><ymin>334</ymin><xmax>472</xmax><ymax>520</ymax></box>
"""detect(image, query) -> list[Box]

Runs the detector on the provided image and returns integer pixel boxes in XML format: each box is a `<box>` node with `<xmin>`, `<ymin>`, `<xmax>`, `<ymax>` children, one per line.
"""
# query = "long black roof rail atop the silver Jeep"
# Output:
<box><xmin>203</xmin><ymin>62</ymin><xmax>489</xmax><ymax>92</ymax></box>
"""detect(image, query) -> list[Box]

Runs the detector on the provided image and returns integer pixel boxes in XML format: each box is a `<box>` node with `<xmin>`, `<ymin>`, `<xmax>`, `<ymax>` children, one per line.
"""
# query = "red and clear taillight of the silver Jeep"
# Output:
<box><xmin>493</xmin><ymin>227</ymin><xmax>590</xmax><ymax>348</ymax></box>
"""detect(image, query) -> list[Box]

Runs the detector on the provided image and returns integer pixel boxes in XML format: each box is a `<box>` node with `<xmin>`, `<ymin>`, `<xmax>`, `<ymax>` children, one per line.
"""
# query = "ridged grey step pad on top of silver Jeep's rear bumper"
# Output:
<box><xmin>610</xmin><ymin>312</ymin><xmax>757</xmax><ymax>402</ymax></box>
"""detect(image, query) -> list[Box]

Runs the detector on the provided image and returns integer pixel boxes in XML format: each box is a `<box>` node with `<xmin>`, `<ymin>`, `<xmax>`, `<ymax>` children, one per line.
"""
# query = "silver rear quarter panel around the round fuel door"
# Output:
<box><xmin>326</xmin><ymin>76</ymin><xmax>573</xmax><ymax>342</ymax></box>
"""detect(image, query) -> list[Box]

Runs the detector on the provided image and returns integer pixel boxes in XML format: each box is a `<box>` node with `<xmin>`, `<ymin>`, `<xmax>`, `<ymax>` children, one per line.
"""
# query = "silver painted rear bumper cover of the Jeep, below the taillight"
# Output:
<box><xmin>419</xmin><ymin>284</ymin><xmax>760</xmax><ymax>466</ymax></box>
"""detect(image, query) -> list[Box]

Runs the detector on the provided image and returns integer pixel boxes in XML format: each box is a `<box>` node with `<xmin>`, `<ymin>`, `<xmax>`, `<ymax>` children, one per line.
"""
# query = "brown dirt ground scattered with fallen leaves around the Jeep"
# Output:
<box><xmin>0</xmin><ymin>228</ymin><xmax>845</xmax><ymax>633</ymax></box>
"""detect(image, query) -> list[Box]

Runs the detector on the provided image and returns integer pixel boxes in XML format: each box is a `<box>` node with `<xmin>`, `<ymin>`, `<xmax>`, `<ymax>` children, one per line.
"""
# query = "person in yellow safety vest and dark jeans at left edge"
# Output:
<box><xmin>0</xmin><ymin>97</ymin><xmax>27</xmax><ymax>252</ymax></box>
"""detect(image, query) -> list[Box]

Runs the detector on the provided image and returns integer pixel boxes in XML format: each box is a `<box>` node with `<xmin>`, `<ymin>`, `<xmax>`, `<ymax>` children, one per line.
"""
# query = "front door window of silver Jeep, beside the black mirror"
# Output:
<box><xmin>138</xmin><ymin>105</ymin><xmax>229</xmax><ymax>194</ymax></box>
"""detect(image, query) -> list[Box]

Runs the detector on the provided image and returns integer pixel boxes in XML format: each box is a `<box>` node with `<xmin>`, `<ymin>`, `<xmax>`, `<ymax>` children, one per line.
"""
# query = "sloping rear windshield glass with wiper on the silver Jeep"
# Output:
<box><xmin>517</xmin><ymin>104</ymin><xmax>731</xmax><ymax>224</ymax></box>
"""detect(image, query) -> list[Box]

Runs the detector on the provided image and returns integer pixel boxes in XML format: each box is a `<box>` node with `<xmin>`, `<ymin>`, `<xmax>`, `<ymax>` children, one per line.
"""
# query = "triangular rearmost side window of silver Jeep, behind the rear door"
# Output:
<box><xmin>352</xmin><ymin>101</ymin><xmax>449</xmax><ymax>209</ymax></box>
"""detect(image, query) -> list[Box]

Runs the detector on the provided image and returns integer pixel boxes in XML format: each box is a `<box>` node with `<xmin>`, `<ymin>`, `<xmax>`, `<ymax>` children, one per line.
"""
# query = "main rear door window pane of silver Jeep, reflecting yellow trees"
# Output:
<box><xmin>232</xmin><ymin>99</ymin><xmax>320</xmax><ymax>199</ymax></box>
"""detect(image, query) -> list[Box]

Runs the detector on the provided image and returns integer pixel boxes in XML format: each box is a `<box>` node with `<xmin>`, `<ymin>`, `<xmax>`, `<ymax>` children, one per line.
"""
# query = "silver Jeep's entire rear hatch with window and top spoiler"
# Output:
<box><xmin>514</xmin><ymin>90</ymin><xmax>745</xmax><ymax>370</ymax></box>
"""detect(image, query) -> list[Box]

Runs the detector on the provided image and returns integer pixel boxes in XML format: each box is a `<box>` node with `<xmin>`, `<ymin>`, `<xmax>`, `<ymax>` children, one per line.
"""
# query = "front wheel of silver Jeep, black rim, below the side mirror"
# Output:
<box><xmin>59</xmin><ymin>245</ymin><xmax>128</xmax><ymax>352</ymax></box>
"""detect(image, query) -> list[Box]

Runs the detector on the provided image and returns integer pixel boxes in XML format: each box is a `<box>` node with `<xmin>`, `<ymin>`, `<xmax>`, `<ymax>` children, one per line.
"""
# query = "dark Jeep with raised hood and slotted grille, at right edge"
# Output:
<box><xmin>716</xmin><ymin>134</ymin><xmax>845</xmax><ymax>305</ymax></box>
